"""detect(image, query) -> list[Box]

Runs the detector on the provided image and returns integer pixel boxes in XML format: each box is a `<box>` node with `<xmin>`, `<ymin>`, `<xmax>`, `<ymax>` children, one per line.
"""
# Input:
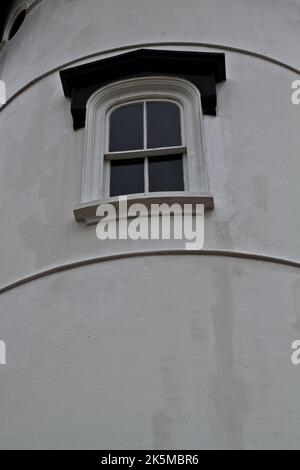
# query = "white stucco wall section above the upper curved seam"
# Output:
<box><xmin>0</xmin><ymin>0</ymin><xmax>300</xmax><ymax>95</ymax></box>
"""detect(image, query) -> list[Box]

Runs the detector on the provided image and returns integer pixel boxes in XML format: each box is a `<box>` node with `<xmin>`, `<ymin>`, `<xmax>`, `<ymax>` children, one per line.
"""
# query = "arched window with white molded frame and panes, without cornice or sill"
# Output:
<box><xmin>82</xmin><ymin>76</ymin><xmax>208</xmax><ymax>206</ymax></box>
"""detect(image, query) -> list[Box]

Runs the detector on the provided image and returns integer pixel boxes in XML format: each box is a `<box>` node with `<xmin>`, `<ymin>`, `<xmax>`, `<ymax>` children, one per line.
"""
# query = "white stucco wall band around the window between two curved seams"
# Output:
<box><xmin>0</xmin><ymin>53</ymin><xmax>300</xmax><ymax>285</ymax></box>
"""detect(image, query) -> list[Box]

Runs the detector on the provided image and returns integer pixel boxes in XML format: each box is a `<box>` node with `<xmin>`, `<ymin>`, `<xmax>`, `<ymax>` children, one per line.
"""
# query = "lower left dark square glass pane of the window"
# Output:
<box><xmin>110</xmin><ymin>158</ymin><xmax>145</xmax><ymax>196</ymax></box>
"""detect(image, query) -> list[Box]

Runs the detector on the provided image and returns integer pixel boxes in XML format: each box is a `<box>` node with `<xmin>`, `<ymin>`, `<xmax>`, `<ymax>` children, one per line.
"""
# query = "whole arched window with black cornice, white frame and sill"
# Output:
<box><xmin>60</xmin><ymin>48</ymin><xmax>226</xmax><ymax>224</ymax></box>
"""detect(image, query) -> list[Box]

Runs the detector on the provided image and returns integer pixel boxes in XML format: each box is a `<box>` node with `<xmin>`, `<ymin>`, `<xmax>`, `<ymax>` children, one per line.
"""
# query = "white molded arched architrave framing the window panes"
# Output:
<box><xmin>81</xmin><ymin>77</ymin><xmax>208</xmax><ymax>203</ymax></box>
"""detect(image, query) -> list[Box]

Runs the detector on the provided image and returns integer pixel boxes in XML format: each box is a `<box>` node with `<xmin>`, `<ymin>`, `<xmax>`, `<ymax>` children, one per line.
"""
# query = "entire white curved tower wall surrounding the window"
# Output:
<box><xmin>0</xmin><ymin>0</ymin><xmax>300</xmax><ymax>448</ymax></box>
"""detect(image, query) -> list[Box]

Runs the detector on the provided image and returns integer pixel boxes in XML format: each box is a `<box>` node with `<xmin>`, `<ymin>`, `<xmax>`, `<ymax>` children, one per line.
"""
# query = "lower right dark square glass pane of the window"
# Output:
<box><xmin>149</xmin><ymin>155</ymin><xmax>184</xmax><ymax>192</ymax></box>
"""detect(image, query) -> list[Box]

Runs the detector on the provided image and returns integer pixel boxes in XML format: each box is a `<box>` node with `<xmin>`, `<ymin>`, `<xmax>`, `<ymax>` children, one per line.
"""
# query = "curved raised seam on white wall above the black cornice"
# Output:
<box><xmin>0</xmin><ymin>41</ymin><xmax>300</xmax><ymax>113</ymax></box>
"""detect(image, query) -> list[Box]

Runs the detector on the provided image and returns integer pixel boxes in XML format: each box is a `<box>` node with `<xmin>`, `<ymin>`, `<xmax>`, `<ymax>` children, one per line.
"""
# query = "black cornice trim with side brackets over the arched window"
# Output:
<box><xmin>60</xmin><ymin>49</ymin><xmax>226</xmax><ymax>129</ymax></box>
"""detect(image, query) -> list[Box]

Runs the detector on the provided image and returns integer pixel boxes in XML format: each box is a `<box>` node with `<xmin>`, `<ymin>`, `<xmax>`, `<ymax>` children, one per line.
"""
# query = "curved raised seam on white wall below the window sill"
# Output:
<box><xmin>0</xmin><ymin>249</ymin><xmax>300</xmax><ymax>295</ymax></box>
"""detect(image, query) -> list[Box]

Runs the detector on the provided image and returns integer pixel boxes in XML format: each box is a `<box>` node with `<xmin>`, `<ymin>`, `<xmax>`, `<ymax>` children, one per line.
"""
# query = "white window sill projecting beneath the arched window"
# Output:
<box><xmin>73</xmin><ymin>192</ymin><xmax>214</xmax><ymax>225</ymax></box>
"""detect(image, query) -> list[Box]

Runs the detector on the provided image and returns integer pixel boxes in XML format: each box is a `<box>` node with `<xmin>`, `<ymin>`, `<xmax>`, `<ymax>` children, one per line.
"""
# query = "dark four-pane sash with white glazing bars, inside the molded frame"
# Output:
<box><xmin>105</xmin><ymin>100</ymin><xmax>186</xmax><ymax>196</ymax></box>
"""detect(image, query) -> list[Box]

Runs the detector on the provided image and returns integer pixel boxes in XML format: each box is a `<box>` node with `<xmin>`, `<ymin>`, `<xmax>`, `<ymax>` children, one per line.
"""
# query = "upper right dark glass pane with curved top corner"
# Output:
<box><xmin>147</xmin><ymin>102</ymin><xmax>181</xmax><ymax>148</ymax></box>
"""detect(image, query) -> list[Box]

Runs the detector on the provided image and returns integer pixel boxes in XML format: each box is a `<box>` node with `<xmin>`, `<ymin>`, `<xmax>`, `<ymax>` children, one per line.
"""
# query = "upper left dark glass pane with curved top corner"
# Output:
<box><xmin>109</xmin><ymin>103</ymin><xmax>144</xmax><ymax>152</ymax></box>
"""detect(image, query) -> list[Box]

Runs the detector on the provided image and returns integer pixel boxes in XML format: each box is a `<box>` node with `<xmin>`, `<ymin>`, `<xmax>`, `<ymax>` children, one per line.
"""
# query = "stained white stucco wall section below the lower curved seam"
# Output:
<box><xmin>0</xmin><ymin>256</ymin><xmax>300</xmax><ymax>449</ymax></box>
